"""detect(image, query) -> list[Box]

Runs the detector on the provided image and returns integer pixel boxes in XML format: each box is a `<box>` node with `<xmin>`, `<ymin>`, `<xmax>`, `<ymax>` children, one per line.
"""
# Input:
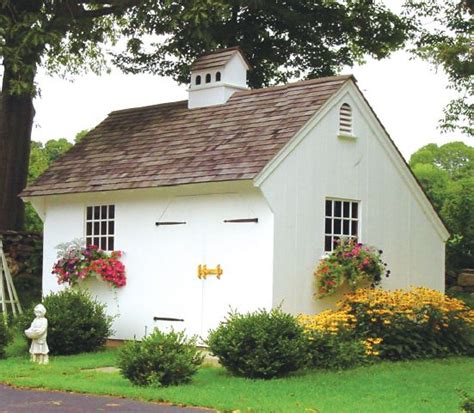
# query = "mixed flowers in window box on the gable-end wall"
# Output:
<box><xmin>314</xmin><ymin>239</ymin><xmax>390</xmax><ymax>298</ymax></box>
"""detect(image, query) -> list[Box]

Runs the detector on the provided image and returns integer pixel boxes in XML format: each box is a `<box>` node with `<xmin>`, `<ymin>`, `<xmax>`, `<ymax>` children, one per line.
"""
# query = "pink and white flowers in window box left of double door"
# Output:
<box><xmin>52</xmin><ymin>240</ymin><xmax>126</xmax><ymax>288</ymax></box>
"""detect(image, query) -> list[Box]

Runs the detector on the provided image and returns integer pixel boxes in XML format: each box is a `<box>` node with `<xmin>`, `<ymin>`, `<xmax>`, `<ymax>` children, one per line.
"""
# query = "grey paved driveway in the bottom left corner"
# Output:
<box><xmin>0</xmin><ymin>384</ymin><xmax>211</xmax><ymax>413</ymax></box>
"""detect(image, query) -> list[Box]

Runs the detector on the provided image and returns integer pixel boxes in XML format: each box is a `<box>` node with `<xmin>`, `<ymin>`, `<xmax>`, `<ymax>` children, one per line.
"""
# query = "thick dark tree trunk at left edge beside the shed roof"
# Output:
<box><xmin>0</xmin><ymin>66</ymin><xmax>35</xmax><ymax>230</ymax></box>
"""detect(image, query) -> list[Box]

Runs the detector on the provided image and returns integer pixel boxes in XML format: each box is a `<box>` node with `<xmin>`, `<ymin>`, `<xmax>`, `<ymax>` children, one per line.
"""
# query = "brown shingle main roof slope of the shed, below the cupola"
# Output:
<box><xmin>21</xmin><ymin>76</ymin><xmax>352</xmax><ymax>196</ymax></box>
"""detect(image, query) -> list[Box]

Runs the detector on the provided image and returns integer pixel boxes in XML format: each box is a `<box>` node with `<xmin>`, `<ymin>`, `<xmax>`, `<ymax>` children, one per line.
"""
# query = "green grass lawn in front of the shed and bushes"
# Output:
<box><xmin>0</xmin><ymin>350</ymin><xmax>474</xmax><ymax>413</ymax></box>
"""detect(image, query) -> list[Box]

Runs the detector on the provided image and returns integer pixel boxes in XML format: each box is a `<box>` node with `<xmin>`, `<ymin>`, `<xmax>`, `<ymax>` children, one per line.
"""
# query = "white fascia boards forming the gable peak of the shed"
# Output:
<box><xmin>254</xmin><ymin>79</ymin><xmax>450</xmax><ymax>242</ymax></box>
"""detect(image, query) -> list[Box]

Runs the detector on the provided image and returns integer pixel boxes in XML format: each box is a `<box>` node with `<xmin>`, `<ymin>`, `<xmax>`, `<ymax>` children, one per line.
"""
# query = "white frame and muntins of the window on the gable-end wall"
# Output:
<box><xmin>323</xmin><ymin>197</ymin><xmax>361</xmax><ymax>253</ymax></box>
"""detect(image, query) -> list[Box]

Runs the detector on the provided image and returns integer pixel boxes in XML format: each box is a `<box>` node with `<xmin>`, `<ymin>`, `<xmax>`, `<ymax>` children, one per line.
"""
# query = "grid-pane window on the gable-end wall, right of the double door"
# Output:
<box><xmin>324</xmin><ymin>199</ymin><xmax>360</xmax><ymax>252</ymax></box>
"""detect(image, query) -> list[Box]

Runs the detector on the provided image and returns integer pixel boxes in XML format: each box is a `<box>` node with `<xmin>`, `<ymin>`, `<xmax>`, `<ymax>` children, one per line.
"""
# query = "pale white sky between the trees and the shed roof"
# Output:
<box><xmin>32</xmin><ymin>0</ymin><xmax>472</xmax><ymax>159</ymax></box>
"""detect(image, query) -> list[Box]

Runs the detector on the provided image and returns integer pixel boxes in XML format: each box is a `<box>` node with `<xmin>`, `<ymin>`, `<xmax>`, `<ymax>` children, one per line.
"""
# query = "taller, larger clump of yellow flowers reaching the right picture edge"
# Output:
<box><xmin>339</xmin><ymin>287</ymin><xmax>474</xmax><ymax>360</ymax></box>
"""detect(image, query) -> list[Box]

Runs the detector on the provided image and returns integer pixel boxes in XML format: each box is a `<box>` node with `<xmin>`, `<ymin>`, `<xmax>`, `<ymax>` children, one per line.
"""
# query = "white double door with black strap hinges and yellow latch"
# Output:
<box><xmin>154</xmin><ymin>194</ymin><xmax>263</xmax><ymax>339</ymax></box>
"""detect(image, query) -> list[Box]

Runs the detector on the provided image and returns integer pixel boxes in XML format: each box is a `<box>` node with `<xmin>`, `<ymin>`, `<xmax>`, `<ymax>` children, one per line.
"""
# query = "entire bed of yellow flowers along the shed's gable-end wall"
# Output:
<box><xmin>297</xmin><ymin>287</ymin><xmax>474</xmax><ymax>360</ymax></box>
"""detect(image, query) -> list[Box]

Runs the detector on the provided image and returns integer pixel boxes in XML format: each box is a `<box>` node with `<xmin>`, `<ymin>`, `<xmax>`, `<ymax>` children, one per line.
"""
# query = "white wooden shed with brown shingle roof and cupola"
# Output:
<box><xmin>22</xmin><ymin>48</ymin><xmax>448</xmax><ymax>339</ymax></box>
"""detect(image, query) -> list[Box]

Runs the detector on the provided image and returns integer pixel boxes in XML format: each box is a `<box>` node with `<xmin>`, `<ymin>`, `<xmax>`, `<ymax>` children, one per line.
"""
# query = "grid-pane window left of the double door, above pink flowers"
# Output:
<box><xmin>86</xmin><ymin>205</ymin><xmax>115</xmax><ymax>251</ymax></box>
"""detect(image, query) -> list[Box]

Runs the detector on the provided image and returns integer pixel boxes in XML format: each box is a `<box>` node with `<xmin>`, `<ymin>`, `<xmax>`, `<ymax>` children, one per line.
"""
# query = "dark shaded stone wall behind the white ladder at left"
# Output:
<box><xmin>0</xmin><ymin>231</ymin><xmax>43</xmax><ymax>308</ymax></box>
